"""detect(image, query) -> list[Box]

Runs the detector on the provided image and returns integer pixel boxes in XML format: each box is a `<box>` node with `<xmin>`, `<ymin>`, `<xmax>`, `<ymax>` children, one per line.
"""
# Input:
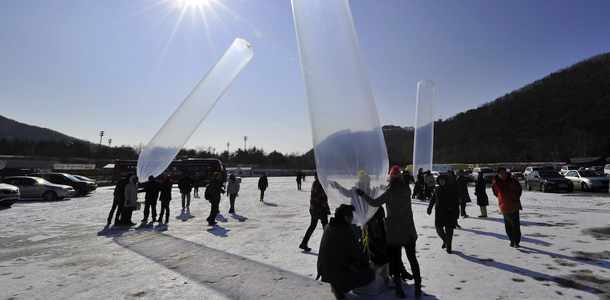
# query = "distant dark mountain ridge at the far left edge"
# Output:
<box><xmin>0</xmin><ymin>115</ymin><xmax>79</xmax><ymax>142</ymax></box>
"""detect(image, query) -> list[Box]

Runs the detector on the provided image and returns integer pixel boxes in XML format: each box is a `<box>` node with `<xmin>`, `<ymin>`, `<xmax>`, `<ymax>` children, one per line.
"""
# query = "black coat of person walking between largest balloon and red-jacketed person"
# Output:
<box><xmin>428</xmin><ymin>182</ymin><xmax>460</xmax><ymax>228</ymax></box>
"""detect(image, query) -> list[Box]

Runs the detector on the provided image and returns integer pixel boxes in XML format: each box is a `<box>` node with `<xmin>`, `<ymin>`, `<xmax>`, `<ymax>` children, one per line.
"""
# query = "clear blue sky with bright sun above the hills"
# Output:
<box><xmin>0</xmin><ymin>0</ymin><xmax>610</xmax><ymax>154</ymax></box>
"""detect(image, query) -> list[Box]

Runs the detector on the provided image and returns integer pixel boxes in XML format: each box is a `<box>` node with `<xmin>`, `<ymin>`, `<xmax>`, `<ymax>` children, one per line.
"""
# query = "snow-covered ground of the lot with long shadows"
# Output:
<box><xmin>0</xmin><ymin>177</ymin><xmax>610</xmax><ymax>299</ymax></box>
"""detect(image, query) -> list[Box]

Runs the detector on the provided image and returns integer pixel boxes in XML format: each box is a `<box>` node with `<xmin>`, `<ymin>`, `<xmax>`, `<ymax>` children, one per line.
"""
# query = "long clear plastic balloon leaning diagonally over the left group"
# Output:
<box><xmin>138</xmin><ymin>38</ymin><xmax>254</xmax><ymax>182</ymax></box>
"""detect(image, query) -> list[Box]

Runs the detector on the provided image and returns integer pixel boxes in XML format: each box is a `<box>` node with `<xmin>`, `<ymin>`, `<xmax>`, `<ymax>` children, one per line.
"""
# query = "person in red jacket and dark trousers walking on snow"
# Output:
<box><xmin>491</xmin><ymin>167</ymin><xmax>523</xmax><ymax>248</ymax></box>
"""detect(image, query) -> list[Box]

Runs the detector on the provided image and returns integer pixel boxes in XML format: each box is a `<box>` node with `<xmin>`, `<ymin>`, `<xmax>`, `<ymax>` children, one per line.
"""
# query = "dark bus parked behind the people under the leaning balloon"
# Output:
<box><xmin>112</xmin><ymin>158</ymin><xmax>226</xmax><ymax>186</ymax></box>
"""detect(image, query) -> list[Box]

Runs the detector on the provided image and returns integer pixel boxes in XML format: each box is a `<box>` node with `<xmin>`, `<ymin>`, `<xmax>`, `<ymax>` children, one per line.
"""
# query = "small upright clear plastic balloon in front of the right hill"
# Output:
<box><xmin>413</xmin><ymin>80</ymin><xmax>434</xmax><ymax>173</ymax></box>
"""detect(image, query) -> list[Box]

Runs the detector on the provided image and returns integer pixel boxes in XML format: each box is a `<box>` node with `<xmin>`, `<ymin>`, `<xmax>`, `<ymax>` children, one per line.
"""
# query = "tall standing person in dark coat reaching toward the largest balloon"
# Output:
<box><xmin>356</xmin><ymin>166</ymin><xmax>421</xmax><ymax>298</ymax></box>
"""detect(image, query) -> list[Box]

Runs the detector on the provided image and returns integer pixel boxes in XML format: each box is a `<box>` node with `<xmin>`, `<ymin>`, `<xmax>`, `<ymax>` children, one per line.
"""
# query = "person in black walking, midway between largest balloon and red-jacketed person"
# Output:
<box><xmin>428</xmin><ymin>175</ymin><xmax>460</xmax><ymax>254</ymax></box>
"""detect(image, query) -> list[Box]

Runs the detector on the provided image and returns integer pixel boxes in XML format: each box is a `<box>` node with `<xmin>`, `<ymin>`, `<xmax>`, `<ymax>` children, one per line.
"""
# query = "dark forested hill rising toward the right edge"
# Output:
<box><xmin>384</xmin><ymin>53</ymin><xmax>610</xmax><ymax>164</ymax></box>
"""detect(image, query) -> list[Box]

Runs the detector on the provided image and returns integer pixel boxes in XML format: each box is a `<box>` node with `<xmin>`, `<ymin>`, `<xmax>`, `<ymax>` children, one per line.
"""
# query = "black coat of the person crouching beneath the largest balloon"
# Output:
<box><xmin>318</xmin><ymin>218</ymin><xmax>368</xmax><ymax>284</ymax></box>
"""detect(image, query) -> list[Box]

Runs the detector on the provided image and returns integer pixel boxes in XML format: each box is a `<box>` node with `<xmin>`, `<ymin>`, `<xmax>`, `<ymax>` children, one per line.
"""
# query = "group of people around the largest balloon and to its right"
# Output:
<box><xmin>299</xmin><ymin>166</ymin><xmax>522</xmax><ymax>299</ymax></box>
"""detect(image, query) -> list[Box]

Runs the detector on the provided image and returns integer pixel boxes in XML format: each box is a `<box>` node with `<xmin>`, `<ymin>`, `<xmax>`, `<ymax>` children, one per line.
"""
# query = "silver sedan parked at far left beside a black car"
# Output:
<box><xmin>2</xmin><ymin>176</ymin><xmax>75</xmax><ymax>200</ymax></box>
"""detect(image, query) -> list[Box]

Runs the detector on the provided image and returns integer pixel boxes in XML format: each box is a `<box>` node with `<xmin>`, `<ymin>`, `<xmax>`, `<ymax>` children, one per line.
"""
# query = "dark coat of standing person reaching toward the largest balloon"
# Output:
<box><xmin>362</xmin><ymin>180</ymin><xmax>417</xmax><ymax>245</ymax></box>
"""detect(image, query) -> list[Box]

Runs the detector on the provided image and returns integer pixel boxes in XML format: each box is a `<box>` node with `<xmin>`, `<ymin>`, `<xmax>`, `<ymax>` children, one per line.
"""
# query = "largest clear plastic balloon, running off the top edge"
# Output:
<box><xmin>292</xmin><ymin>0</ymin><xmax>388</xmax><ymax>225</ymax></box>
